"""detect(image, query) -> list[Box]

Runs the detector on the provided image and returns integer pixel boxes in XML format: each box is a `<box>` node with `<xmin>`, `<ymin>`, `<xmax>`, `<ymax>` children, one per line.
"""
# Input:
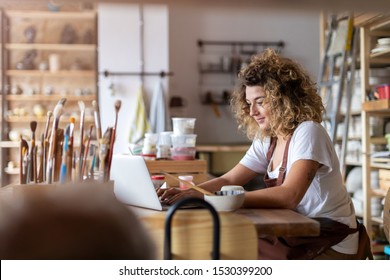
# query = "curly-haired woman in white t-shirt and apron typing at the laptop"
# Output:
<box><xmin>159</xmin><ymin>49</ymin><xmax>359</xmax><ymax>259</ymax></box>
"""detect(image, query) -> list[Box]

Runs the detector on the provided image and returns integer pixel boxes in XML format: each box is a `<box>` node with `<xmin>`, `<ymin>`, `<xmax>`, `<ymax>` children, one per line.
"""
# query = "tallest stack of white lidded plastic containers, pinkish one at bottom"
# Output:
<box><xmin>171</xmin><ymin>118</ymin><xmax>197</xmax><ymax>160</ymax></box>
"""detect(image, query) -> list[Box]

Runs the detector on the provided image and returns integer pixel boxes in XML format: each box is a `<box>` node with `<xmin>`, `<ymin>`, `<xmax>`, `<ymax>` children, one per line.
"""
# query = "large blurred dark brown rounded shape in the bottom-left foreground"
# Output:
<box><xmin>0</xmin><ymin>186</ymin><xmax>154</xmax><ymax>260</ymax></box>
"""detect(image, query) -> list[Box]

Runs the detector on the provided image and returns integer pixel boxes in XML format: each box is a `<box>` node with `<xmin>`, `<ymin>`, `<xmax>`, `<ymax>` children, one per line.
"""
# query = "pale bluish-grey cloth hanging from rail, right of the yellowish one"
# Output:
<box><xmin>149</xmin><ymin>79</ymin><xmax>171</xmax><ymax>133</ymax></box>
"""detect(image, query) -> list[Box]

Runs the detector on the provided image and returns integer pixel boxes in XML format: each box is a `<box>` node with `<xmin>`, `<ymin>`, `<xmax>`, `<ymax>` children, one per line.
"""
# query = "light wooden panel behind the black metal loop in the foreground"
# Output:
<box><xmin>141</xmin><ymin>203</ymin><xmax>257</xmax><ymax>260</ymax></box>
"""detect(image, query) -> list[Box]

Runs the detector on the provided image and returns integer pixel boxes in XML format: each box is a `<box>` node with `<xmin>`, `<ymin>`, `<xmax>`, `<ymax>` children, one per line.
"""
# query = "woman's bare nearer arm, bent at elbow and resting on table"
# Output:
<box><xmin>244</xmin><ymin>160</ymin><xmax>321</xmax><ymax>209</ymax></box>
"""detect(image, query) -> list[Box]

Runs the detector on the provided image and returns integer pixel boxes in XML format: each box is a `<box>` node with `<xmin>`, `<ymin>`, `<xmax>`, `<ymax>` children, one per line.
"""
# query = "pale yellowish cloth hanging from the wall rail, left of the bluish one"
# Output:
<box><xmin>129</xmin><ymin>86</ymin><xmax>150</xmax><ymax>143</ymax></box>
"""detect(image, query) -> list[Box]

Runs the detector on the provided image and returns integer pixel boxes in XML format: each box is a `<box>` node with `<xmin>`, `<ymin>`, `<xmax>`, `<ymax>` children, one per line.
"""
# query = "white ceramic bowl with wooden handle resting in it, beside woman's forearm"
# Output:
<box><xmin>204</xmin><ymin>187</ymin><xmax>245</xmax><ymax>212</ymax></box>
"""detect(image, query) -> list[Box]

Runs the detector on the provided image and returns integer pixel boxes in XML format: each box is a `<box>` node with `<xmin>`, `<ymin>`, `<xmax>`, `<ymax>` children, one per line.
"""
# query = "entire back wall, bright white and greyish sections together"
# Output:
<box><xmin>99</xmin><ymin>2</ymin><xmax>320</xmax><ymax>149</ymax></box>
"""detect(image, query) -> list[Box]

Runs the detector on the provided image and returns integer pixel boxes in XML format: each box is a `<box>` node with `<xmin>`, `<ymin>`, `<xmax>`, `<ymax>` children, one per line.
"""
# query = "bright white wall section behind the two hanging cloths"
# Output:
<box><xmin>98</xmin><ymin>4</ymin><xmax>169</xmax><ymax>153</ymax></box>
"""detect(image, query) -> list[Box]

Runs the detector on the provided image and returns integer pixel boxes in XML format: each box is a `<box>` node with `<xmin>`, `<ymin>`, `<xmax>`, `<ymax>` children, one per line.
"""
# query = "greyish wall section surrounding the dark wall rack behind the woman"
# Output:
<box><xmin>169</xmin><ymin>4</ymin><xmax>320</xmax><ymax>143</ymax></box>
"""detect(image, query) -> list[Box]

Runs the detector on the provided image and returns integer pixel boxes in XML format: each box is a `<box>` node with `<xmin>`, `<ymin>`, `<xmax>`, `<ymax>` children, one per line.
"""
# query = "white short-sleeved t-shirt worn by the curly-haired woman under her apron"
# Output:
<box><xmin>240</xmin><ymin>121</ymin><xmax>359</xmax><ymax>254</ymax></box>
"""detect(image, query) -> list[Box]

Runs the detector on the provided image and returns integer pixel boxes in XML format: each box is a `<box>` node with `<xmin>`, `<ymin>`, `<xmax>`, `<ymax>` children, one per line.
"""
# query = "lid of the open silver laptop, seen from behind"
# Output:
<box><xmin>110</xmin><ymin>154</ymin><xmax>166</xmax><ymax>211</ymax></box>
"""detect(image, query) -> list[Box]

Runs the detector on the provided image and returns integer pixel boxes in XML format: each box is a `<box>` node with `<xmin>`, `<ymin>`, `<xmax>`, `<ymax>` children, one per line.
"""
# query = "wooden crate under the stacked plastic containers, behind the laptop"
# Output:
<box><xmin>145</xmin><ymin>160</ymin><xmax>208</xmax><ymax>187</ymax></box>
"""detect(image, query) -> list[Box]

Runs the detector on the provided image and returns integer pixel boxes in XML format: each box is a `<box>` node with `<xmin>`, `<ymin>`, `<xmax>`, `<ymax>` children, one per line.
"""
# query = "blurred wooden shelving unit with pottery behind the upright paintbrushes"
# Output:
<box><xmin>0</xmin><ymin>9</ymin><xmax>98</xmax><ymax>186</ymax></box>
